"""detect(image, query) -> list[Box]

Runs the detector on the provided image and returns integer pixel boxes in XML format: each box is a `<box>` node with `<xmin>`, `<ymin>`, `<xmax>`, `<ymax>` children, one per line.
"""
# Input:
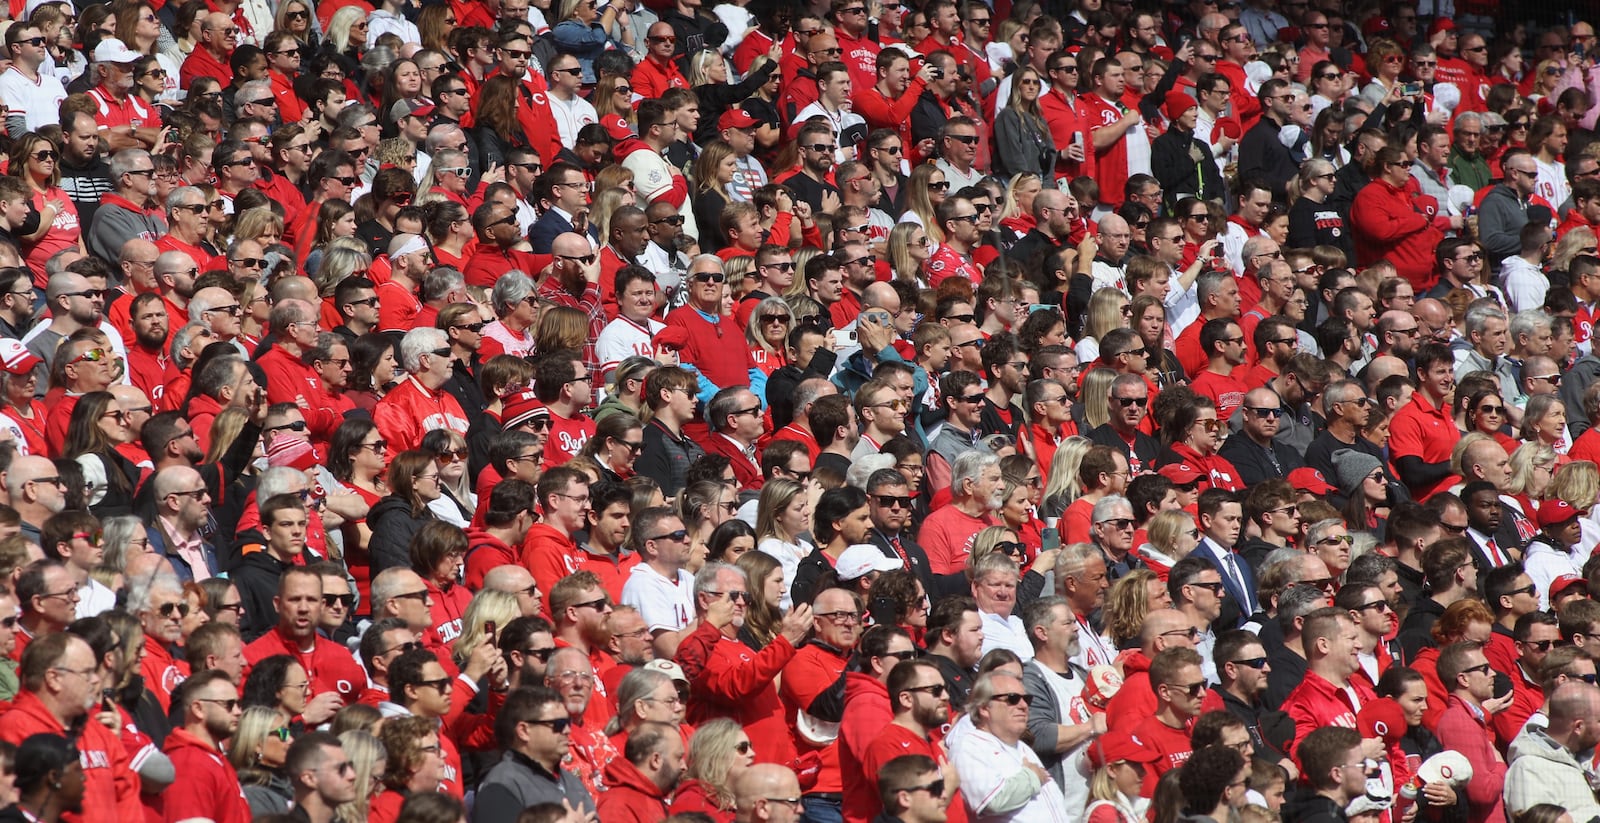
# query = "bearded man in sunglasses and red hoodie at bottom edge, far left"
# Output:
<box><xmin>158</xmin><ymin>669</ymin><xmax>251</xmax><ymax>823</ymax></box>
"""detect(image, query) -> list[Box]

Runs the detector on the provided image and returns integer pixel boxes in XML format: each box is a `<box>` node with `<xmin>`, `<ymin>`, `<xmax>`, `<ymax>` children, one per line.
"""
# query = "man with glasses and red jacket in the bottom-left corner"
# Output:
<box><xmin>0</xmin><ymin>632</ymin><xmax>144</xmax><ymax>823</ymax></box>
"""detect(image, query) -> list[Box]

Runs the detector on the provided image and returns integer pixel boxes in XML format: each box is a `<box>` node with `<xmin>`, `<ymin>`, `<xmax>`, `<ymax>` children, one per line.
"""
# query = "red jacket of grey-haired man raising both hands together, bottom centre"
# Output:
<box><xmin>675</xmin><ymin>621</ymin><xmax>795</xmax><ymax>765</ymax></box>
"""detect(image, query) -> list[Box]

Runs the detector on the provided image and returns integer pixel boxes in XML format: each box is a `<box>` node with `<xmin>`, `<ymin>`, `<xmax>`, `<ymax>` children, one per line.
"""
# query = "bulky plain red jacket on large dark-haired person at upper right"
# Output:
<box><xmin>1350</xmin><ymin>178</ymin><xmax>1445</xmax><ymax>291</ymax></box>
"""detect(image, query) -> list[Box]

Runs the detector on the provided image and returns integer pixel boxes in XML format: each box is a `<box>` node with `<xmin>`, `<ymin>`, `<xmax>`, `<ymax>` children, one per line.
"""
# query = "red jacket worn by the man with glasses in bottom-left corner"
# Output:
<box><xmin>0</xmin><ymin>690</ymin><xmax>144</xmax><ymax>823</ymax></box>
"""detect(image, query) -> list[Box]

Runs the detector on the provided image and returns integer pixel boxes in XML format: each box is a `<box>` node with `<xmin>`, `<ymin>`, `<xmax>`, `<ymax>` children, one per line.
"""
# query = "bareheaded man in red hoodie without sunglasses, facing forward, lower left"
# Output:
<box><xmin>245</xmin><ymin>565</ymin><xmax>366</xmax><ymax>704</ymax></box>
